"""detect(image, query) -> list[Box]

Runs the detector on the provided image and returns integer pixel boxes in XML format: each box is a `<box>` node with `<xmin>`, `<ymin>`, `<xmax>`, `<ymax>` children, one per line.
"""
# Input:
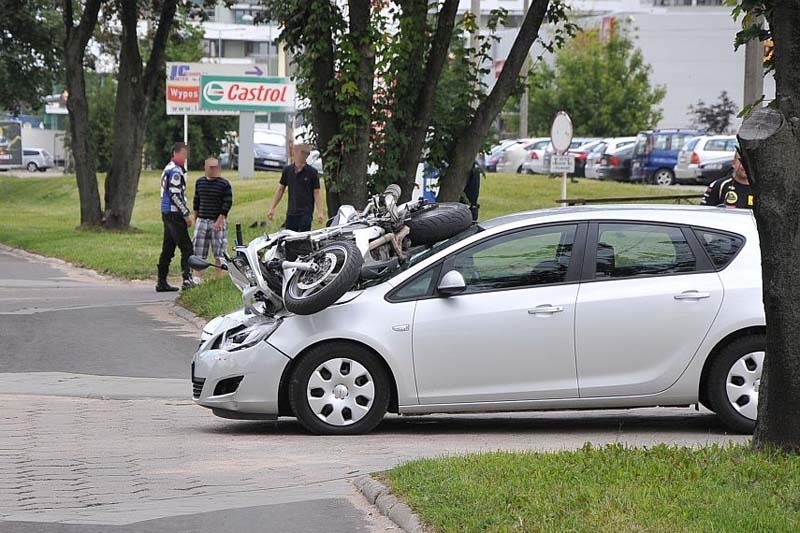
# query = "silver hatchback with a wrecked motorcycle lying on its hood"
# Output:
<box><xmin>192</xmin><ymin>205</ymin><xmax>765</xmax><ymax>434</ymax></box>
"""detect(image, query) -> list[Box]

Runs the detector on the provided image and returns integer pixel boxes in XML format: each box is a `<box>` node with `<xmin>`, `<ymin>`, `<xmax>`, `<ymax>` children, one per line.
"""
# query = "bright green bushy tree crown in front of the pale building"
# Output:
<box><xmin>528</xmin><ymin>26</ymin><xmax>666</xmax><ymax>136</ymax></box>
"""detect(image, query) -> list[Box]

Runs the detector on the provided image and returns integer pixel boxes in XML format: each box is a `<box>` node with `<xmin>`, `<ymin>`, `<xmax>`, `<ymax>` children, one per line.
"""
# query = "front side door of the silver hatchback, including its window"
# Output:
<box><xmin>413</xmin><ymin>224</ymin><xmax>585</xmax><ymax>404</ymax></box>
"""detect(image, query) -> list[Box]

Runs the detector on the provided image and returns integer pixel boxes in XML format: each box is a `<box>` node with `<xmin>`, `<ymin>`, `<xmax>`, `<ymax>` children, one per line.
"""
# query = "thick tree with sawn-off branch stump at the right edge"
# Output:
<box><xmin>734</xmin><ymin>0</ymin><xmax>800</xmax><ymax>453</ymax></box>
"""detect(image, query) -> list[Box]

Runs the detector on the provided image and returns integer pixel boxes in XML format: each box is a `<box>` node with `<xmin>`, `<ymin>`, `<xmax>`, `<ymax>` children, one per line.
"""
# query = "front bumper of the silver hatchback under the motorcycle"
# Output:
<box><xmin>192</xmin><ymin>336</ymin><xmax>290</xmax><ymax>420</ymax></box>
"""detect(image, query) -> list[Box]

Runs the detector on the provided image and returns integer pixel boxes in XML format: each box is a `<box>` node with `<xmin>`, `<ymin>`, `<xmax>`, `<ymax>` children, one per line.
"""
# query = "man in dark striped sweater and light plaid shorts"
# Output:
<box><xmin>194</xmin><ymin>157</ymin><xmax>233</xmax><ymax>277</ymax></box>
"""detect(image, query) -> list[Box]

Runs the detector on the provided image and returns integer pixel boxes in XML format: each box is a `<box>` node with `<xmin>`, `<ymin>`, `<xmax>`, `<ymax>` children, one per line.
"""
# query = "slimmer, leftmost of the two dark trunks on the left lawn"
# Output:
<box><xmin>61</xmin><ymin>0</ymin><xmax>103</xmax><ymax>227</ymax></box>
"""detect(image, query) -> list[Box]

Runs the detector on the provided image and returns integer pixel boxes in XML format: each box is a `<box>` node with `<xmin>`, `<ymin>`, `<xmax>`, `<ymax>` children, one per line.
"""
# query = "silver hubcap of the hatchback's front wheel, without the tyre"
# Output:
<box><xmin>306</xmin><ymin>357</ymin><xmax>375</xmax><ymax>427</ymax></box>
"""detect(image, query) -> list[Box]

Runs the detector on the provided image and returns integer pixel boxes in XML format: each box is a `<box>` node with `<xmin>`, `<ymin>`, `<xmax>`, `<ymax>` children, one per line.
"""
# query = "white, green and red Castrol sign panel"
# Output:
<box><xmin>200</xmin><ymin>75</ymin><xmax>295</xmax><ymax>112</ymax></box>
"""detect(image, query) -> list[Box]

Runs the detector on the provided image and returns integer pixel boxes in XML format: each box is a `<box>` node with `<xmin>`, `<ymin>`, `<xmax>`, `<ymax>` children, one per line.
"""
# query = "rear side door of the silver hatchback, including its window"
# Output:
<box><xmin>575</xmin><ymin>222</ymin><xmax>723</xmax><ymax>397</ymax></box>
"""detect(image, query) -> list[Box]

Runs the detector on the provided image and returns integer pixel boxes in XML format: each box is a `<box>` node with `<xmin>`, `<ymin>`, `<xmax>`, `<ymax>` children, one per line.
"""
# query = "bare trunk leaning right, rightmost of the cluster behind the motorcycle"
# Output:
<box><xmin>438</xmin><ymin>0</ymin><xmax>550</xmax><ymax>202</ymax></box>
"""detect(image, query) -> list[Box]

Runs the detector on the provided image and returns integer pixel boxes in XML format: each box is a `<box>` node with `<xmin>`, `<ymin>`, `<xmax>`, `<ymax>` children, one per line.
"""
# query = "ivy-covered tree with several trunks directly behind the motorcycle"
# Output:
<box><xmin>263</xmin><ymin>0</ymin><xmax>566</xmax><ymax>211</ymax></box>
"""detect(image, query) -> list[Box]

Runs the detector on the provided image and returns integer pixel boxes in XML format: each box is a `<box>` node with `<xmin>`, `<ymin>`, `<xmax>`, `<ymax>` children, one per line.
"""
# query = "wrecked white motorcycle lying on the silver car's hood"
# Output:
<box><xmin>189</xmin><ymin>185</ymin><xmax>472</xmax><ymax>316</ymax></box>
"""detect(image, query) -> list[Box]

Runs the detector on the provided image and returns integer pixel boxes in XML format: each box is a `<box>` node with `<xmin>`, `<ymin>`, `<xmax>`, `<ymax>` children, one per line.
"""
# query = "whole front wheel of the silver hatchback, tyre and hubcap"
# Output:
<box><xmin>289</xmin><ymin>342</ymin><xmax>391</xmax><ymax>435</ymax></box>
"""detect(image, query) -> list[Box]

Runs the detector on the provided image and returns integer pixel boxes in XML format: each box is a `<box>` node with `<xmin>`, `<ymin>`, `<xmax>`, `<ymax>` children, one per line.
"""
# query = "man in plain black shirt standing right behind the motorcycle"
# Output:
<box><xmin>267</xmin><ymin>144</ymin><xmax>325</xmax><ymax>231</ymax></box>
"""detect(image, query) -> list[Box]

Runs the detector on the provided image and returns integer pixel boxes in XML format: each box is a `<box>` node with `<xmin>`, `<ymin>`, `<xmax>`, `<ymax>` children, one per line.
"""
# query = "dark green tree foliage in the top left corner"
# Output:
<box><xmin>0</xmin><ymin>0</ymin><xmax>64</xmax><ymax>113</ymax></box>
